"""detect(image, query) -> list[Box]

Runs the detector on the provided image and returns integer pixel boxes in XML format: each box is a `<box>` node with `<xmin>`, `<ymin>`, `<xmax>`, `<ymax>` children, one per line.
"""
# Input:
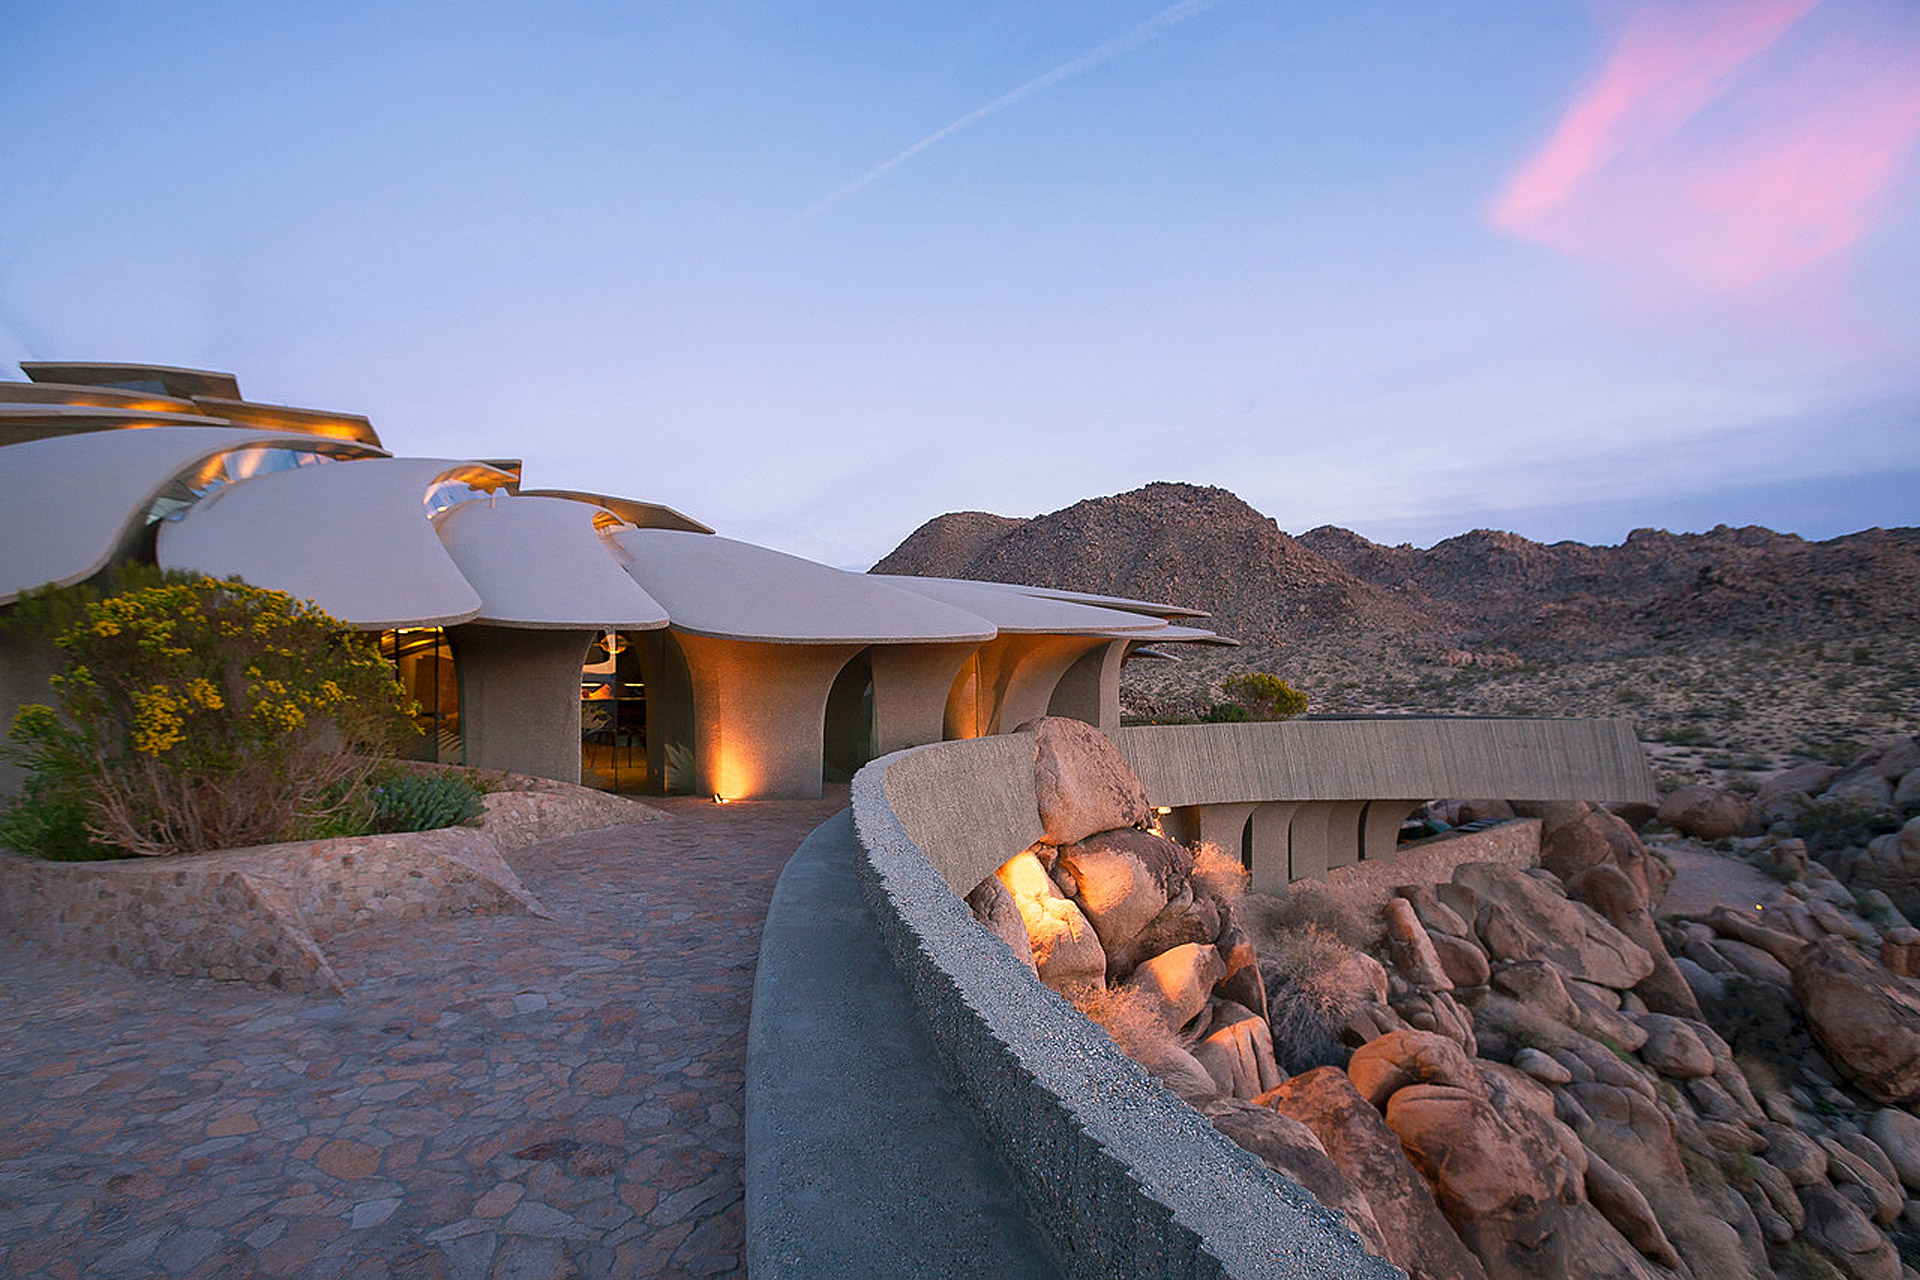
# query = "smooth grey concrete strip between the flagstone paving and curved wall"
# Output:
<box><xmin>747</xmin><ymin>814</ymin><xmax>1060</xmax><ymax>1280</ymax></box>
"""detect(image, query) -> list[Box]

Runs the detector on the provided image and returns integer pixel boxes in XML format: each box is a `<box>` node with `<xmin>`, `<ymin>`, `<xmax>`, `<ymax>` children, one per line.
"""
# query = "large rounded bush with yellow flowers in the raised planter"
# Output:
<box><xmin>6</xmin><ymin>574</ymin><xmax>413</xmax><ymax>856</ymax></box>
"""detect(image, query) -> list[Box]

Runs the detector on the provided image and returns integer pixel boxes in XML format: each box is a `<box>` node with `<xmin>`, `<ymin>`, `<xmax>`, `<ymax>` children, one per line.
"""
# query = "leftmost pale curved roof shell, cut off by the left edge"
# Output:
<box><xmin>0</xmin><ymin>426</ymin><xmax>374</xmax><ymax>604</ymax></box>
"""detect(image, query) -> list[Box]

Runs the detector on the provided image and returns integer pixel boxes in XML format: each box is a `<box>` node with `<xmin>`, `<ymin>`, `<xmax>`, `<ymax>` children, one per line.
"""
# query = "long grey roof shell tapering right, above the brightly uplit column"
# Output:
<box><xmin>607</xmin><ymin>530</ymin><xmax>995</xmax><ymax>645</ymax></box>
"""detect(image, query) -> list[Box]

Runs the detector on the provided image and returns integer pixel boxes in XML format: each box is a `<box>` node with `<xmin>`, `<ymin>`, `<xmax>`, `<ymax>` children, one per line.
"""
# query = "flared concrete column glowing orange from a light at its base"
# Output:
<box><xmin>676</xmin><ymin>631</ymin><xmax>862</xmax><ymax>800</ymax></box>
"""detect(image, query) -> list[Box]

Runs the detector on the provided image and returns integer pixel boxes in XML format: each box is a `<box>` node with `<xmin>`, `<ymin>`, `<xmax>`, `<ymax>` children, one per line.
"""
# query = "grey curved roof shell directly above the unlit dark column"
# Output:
<box><xmin>434</xmin><ymin>497</ymin><xmax>666</xmax><ymax>631</ymax></box>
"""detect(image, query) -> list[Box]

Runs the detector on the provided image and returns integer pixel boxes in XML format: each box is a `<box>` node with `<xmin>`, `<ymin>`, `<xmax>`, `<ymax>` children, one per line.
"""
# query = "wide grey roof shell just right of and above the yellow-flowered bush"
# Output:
<box><xmin>157</xmin><ymin>454</ymin><xmax>505</xmax><ymax>631</ymax></box>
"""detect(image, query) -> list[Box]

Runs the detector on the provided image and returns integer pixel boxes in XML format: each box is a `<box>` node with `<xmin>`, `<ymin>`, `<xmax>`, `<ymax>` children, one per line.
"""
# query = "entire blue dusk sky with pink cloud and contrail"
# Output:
<box><xmin>0</xmin><ymin>0</ymin><xmax>1920</xmax><ymax>568</ymax></box>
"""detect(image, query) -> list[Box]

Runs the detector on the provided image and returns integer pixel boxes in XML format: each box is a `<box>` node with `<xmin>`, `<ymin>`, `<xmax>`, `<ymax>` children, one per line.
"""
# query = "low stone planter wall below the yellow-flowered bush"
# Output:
<box><xmin>0</xmin><ymin>789</ymin><xmax>662</xmax><ymax>994</ymax></box>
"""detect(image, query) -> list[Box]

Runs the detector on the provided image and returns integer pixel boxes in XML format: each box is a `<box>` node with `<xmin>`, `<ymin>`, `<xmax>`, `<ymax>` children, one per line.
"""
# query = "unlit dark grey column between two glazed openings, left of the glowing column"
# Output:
<box><xmin>447</xmin><ymin>624</ymin><xmax>597</xmax><ymax>783</ymax></box>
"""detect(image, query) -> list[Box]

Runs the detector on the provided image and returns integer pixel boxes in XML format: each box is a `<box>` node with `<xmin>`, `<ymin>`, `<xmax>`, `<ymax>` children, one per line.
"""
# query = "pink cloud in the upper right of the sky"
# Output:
<box><xmin>1490</xmin><ymin>0</ymin><xmax>1920</xmax><ymax>290</ymax></box>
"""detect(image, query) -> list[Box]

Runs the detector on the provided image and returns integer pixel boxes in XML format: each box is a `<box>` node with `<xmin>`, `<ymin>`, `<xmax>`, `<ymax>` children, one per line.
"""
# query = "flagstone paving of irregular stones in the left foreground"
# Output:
<box><xmin>0</xmin><ymin>787</ymin><xmax>847</xmax><ymax>1280</ymax></box>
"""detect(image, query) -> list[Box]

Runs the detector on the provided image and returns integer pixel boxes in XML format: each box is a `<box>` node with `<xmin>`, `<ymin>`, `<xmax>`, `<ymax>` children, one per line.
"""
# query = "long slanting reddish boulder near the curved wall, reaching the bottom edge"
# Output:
<box><xmin>1260</xmin><ymin>1067</ymin><xmax>1486</xmax><ymax>1280</ymax></box>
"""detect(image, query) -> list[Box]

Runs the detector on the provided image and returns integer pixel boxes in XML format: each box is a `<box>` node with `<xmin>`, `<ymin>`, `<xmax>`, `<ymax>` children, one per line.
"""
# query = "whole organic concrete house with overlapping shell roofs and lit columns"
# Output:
<box><xmin>0</xmin><ymin>363</ymin><xmax>1223</xmax><ymax>798</ymax></box>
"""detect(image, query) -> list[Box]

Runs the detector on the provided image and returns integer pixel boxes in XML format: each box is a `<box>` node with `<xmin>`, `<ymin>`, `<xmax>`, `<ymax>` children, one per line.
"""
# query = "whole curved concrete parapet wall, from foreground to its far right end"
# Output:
<box><xmin>852</xmin><ymin>720</ymin><xmax>1651</xmax><ymax>1278</ymax></box>
